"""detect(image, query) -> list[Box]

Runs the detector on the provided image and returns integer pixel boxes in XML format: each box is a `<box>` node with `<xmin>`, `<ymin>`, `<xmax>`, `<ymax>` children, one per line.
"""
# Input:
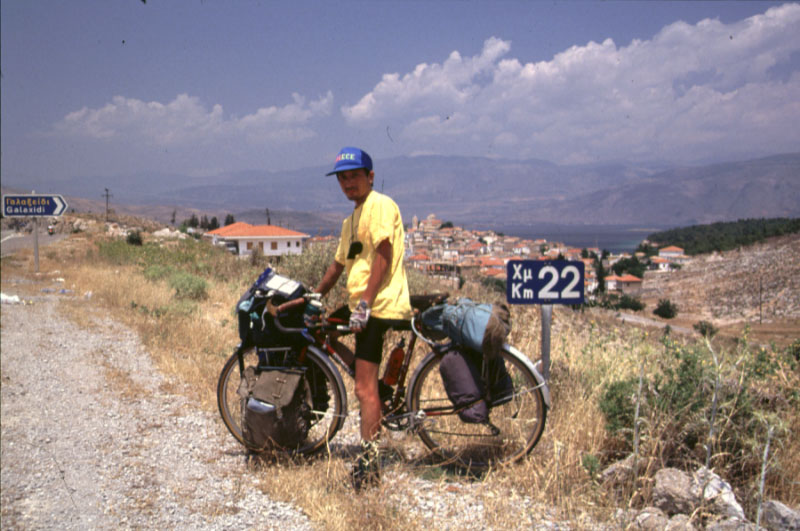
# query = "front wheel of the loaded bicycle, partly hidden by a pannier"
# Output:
<box><xmin>217</xmin><ymin>348</ymin><xmax>347</xmax><ymax>454</ymax></box>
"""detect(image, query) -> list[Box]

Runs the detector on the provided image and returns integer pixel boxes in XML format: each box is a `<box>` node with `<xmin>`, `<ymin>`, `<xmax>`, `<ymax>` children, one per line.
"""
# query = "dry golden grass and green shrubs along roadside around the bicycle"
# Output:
<box><xmin>2</xmin><ymin>215</ymin><xmax>800</xmax><ymax>529</ymax></box>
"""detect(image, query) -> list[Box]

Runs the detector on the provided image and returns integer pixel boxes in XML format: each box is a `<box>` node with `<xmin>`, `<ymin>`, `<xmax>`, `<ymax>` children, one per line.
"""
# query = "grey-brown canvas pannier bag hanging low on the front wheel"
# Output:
<box><xmin>238</xmin><ymin>366</ymin><xmax>311</xmax><ymax>451</ymax></box>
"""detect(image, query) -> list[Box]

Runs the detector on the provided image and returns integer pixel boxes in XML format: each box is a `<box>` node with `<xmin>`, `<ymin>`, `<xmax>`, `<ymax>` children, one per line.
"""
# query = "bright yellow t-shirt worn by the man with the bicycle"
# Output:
<box><xmin>335</xmin><ymin>190</ymin><xmax>411</xmax><ymax>319</ymax></box>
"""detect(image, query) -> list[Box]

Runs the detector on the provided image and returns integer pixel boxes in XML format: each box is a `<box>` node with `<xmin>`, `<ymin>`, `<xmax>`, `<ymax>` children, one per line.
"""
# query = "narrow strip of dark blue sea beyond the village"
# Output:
<box><xmin>488</xmin><ymin>224</ymin><xmax>669</xmax><ymax>253</ymax></box>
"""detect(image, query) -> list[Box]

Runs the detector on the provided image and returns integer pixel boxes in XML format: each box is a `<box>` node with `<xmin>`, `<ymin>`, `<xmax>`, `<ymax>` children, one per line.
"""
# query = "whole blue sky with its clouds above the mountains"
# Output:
<box><xmin>0</xmin><ymin>0</ymin><xmax>800</xmax><ymax>183</ymax></box>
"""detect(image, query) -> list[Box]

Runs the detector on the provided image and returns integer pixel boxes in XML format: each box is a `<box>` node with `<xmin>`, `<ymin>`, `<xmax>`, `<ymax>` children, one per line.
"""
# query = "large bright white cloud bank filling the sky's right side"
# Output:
<box><xmin>341</xmin><ymin>4</ymin><xmax>800</xmax><ymax>162</ymax></box>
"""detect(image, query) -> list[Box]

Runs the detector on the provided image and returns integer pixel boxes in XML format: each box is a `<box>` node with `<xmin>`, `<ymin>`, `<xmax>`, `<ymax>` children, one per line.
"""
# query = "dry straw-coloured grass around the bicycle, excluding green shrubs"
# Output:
<box><xmin>2</xmin><ymin>224</ymin><xmax>800</xmax><ymax>530</ymax></box>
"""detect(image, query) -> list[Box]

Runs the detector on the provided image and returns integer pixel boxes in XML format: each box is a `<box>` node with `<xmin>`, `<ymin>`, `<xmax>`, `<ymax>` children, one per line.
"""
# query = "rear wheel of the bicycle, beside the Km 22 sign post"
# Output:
<box><xmin>408</xmin><ymin>348</ymin><xmax>547</xmax><ymax>470</ymax></box>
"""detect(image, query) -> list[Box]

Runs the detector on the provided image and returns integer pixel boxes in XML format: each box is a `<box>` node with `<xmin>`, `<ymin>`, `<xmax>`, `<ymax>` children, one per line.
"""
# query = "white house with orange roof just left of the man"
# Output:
<box><xmin>203</xmin><ymin>221</ymin><xmax>310</xmax><ymax>256</ymax></box>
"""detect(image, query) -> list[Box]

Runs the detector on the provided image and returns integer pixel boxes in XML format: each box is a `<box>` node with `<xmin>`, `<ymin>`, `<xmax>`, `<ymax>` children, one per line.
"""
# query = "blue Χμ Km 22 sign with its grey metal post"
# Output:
<box><xmin>506</xmin><ymin>260</ymin><xmax>585</xmax><ymax>381</ymax></box>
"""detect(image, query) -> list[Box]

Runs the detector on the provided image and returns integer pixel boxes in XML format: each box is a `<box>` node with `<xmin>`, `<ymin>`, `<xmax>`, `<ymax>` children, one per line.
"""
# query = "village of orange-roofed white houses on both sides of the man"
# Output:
<box><xmin>203</xmin><ymin>214</ymin><xmax>689</xmax><ymax>297</ymax></box>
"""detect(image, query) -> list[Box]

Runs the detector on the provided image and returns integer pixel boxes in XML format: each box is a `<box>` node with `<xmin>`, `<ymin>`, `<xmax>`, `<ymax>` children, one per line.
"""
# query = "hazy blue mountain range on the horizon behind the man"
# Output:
<box><xmin>3</xmin><ymin>153</ymin><xmax>800</xmax><ymax>232</ymax></box>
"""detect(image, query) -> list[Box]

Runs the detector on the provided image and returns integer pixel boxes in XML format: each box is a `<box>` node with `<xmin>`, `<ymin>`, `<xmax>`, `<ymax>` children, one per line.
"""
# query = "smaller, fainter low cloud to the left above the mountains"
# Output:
<box><xmin>54</xmin><ymin>92</ymin><xmax>333</xmax><ymax>148</ymax></box>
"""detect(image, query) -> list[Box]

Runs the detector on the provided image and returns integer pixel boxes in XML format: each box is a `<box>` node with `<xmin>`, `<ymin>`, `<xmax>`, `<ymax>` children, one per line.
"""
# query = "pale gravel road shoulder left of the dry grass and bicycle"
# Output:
<box><xmin>0</xmin><ymin>295</ymin><xmax>312</xmax><ymax>529</ymax></box>
